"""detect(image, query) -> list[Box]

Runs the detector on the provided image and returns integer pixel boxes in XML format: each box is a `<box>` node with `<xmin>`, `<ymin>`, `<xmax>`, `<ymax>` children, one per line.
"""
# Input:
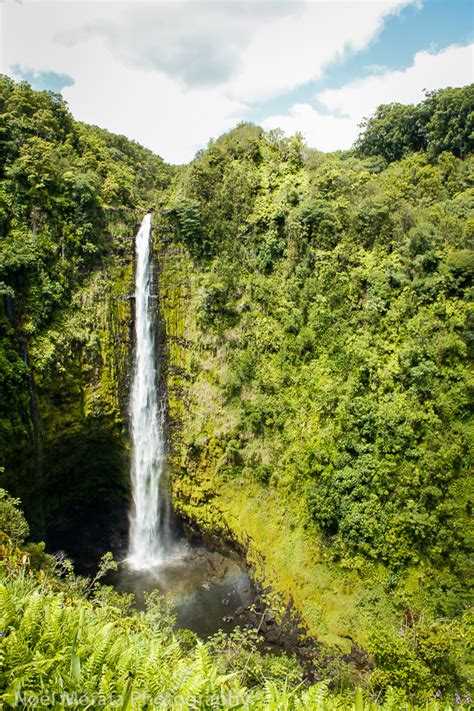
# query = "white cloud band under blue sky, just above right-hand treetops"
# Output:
<box><xmin>263</xmin><ymin>44</ymin><xmax>474</xmax><ymax>151</ymax></box>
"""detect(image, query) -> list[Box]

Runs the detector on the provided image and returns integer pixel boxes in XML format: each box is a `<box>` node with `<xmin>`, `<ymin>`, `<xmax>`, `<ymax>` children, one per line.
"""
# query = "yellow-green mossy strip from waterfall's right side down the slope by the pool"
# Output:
<box><xmin>156</xmin><ymin>239</ymin><xmax>380</xmax><ymax>651</ymax></box>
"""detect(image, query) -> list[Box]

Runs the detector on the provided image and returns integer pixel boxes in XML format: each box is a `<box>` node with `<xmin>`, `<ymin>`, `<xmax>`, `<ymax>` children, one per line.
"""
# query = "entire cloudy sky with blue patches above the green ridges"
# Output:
<box><xmin>0</xmin><ymin>0</ymin><xmax>474</xmax><ymax>163</ymax></box>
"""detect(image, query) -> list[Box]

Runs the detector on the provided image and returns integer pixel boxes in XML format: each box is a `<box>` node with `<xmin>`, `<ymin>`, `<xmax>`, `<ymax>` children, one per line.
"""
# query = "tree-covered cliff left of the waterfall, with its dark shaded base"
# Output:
<box><xmin>0</xmin><ymin>77</ymin><xmax>171</xmax><ymax>533</ymax></box>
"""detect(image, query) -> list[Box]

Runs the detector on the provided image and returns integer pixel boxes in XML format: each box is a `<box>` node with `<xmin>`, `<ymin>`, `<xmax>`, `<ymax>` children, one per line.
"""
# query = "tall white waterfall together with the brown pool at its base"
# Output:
<box><xmin>120</xmin><ymin>211</ymin><xmax>260</xmax><ymax>635</ymax></box>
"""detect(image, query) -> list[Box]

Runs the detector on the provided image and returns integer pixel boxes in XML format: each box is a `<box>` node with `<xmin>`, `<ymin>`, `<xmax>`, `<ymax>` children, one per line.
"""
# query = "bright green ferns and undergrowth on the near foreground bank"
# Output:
<box><xmin>0</xmin><ymin>538</ymin><xmax>470</xmax><ymax>711</ymax></box>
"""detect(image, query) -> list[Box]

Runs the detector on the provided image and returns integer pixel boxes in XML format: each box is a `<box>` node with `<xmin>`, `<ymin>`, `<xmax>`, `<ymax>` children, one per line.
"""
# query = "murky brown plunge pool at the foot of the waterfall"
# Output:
<box><xmin>111</xmin><ymin>540</ymin><xmax>255</xmax><ymax>637</ymax></box>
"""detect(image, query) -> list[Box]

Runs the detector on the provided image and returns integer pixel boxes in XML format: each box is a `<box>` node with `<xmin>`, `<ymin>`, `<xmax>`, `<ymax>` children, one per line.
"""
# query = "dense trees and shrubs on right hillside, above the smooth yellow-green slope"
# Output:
<box><xmin>166</xmin><ymin>87</ymin><xmax>474</xmax><ymax>580</ymax></box>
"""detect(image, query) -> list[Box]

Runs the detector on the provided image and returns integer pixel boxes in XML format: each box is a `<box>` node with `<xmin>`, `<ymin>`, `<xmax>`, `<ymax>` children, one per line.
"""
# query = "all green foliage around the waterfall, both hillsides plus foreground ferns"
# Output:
<box><xmin>0</xmin><ymin>78</ymin><xmax>474</xmax><ymax>711</ymax></box>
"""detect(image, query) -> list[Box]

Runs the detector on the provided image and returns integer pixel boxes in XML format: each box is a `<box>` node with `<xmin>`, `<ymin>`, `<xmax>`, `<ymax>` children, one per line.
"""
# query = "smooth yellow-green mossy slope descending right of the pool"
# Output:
<box><xmin>173</xmin><ymin>470</ymin><xmax>395</xmax><ymax>652</ymax></box>
